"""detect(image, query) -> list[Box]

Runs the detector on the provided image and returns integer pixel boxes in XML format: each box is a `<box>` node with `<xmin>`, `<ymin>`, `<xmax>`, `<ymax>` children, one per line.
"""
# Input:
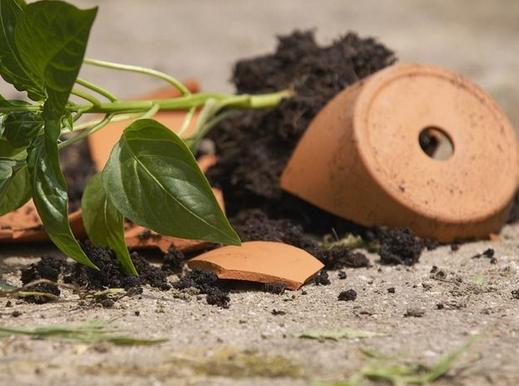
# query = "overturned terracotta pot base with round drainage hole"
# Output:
<box><xmin>281</xmin><ymin>64</ymin><xmax>519</xmax><ymax>242</ymax></box>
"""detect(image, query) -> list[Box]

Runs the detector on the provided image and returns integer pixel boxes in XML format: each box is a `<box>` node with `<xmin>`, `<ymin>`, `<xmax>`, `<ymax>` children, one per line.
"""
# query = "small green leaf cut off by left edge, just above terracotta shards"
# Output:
<box><xmin>0</xmin><ymin>160</ymin><xmax>31</xmax><ymax>216</ymax></box>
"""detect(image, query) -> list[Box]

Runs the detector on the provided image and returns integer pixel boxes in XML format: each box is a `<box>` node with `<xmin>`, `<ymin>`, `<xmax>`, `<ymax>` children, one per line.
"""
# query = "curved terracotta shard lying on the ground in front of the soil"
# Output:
<box><xmin>188</xmin><ymin>241</ymin><xmax>324</xmax><ymax>290</ymax></box>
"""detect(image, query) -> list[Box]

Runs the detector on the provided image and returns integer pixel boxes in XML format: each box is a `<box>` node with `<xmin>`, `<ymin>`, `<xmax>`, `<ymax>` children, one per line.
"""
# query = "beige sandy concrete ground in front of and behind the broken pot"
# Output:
<box><xmin>0</xmin><ymin>0</ymin><xmax>519</xmax><ymax>385</ymax></box>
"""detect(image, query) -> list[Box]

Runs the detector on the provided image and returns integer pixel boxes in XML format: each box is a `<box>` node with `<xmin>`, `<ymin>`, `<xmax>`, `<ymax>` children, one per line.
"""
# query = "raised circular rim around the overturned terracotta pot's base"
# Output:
<box><xmin>352</xmin><ymin>63</ymin><xmax>519</xmax><ymax>225</ymax></box>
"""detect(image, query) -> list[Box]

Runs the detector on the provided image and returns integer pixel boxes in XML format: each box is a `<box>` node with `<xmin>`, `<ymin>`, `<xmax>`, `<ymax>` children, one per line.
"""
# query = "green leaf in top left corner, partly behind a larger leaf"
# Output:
<box><xmin>0</xmin><ymin>0</ymin><xmax>45</xmax><ymax>100</ymax></box>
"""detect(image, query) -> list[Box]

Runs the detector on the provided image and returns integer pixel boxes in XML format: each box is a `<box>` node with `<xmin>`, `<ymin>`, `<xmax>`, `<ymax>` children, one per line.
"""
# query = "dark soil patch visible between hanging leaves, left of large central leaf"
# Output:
<box><xmin>59</xmin><ymin>141</ymin><xmax>96</xmax><ymax>212</ymax></box>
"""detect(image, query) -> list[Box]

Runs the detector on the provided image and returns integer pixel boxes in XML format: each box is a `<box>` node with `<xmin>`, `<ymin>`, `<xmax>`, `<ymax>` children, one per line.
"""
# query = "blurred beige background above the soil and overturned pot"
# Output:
<box><xmin>9</xmin><ymin>0</ymin><xmax>519</xmax><ymax>128</ymax></box>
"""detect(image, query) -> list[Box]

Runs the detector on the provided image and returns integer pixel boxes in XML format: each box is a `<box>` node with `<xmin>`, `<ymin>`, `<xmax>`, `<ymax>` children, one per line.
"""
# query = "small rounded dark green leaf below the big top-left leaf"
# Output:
<box><xmin>2</xmin><ymin>111</ymin><xmax>43</xmax><ymax>148</ymax></box>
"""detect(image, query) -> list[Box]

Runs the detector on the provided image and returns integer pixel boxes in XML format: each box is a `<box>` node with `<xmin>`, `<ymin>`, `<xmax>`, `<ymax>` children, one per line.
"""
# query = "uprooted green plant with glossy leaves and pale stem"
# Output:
<box><xmin>0</xmin><ymin>0</ymin><xmax>289</xmax><ymax>274</ymax></box>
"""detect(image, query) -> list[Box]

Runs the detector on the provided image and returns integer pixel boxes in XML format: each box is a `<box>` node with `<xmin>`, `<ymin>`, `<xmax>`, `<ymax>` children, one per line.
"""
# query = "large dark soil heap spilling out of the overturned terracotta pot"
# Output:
<box><xmin>208</xmin><ymin>31</ymin><xmax>430</xmax><ymax>269</ymax></box>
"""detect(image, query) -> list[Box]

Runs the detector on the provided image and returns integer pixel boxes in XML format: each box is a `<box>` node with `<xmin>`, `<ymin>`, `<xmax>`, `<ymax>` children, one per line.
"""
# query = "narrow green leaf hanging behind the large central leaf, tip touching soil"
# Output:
<box><xmin>81</xmin><ymin>174</ymin><xmax>137</xmax><ymax>275</ymax></box>
